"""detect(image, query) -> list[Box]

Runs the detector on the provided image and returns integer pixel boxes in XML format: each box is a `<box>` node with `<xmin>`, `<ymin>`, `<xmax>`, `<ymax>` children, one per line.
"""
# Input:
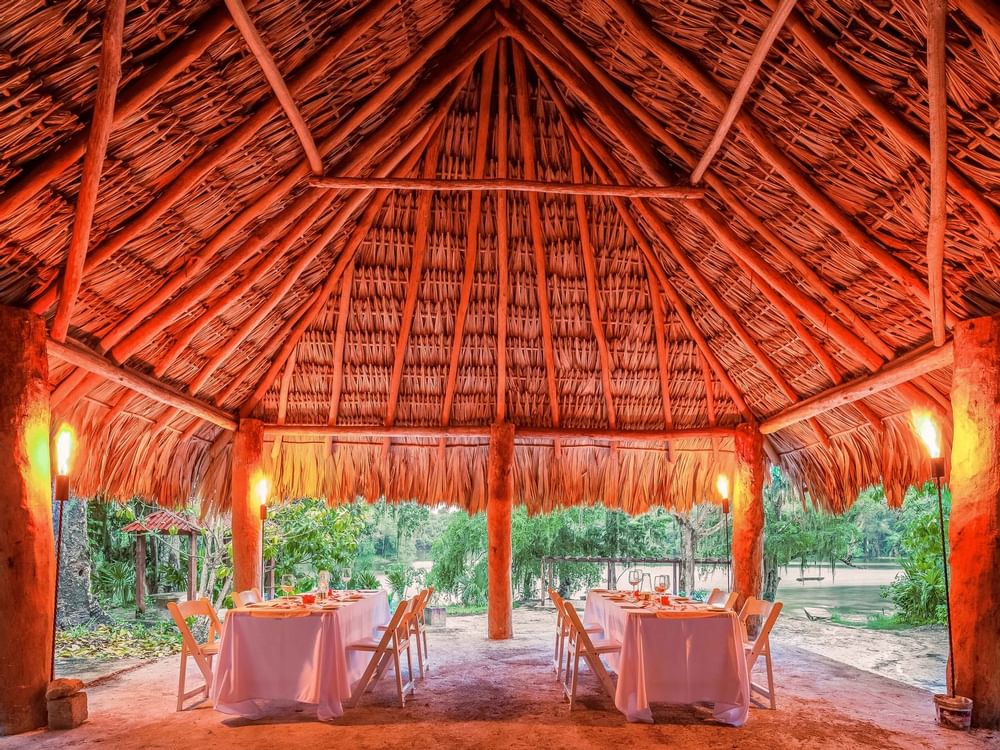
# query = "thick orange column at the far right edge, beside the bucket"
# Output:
<box><xmin>949</xmin><ymin>318</ymin><xmax>1000</xmax><ymax>729</ymax></box>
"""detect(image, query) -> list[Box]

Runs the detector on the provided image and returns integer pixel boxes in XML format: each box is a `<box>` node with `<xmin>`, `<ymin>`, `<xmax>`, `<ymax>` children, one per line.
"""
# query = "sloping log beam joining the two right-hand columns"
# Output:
<box><xmin>760</xmin><ymin>341</ymin><xmax>955</xmax><ymax>434</ymax></box>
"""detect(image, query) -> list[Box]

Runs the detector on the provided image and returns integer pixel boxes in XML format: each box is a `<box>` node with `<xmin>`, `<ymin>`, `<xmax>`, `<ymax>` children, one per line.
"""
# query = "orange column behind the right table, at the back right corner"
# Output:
<box><xmin>733</xmin><ymin>424</ymin><xmax>766</xmax><ymax>606</ymax></box>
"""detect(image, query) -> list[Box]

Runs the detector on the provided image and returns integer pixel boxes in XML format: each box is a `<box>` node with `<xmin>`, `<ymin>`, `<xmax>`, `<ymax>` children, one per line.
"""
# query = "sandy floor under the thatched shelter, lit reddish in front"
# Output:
<box><xmin>0</xmin><ymin>610</ymin><xmax>1000</xmax><ymax>750</ymax></box>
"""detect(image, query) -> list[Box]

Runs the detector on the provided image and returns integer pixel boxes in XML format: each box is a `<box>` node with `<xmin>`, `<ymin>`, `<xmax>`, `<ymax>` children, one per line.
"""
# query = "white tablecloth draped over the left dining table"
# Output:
<box><xmin>212</xmin><ymin>591</ymin><xmax>389</xmax><ymax>721</ymax></box>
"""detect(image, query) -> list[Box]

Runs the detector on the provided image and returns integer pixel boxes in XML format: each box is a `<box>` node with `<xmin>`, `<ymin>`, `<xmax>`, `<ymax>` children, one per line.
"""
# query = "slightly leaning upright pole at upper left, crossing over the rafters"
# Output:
<box><xmin>51</xmin><ymin>0</ymin><xmax>125</xmax><ymax>341</ymax></box>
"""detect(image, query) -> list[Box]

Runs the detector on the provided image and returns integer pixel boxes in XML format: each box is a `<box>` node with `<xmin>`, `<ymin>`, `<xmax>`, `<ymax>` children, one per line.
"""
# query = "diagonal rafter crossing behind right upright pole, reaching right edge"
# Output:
<box><xmin>765</xmin><ymin>0</ymin><xmax>1000</xmax><ymax>238</ymax></box>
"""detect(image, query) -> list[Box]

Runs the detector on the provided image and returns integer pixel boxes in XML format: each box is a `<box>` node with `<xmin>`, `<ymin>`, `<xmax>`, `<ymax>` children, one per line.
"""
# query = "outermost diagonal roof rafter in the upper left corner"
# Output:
<box><xmin>0</xmin><ymin>7</ymin><xmax>232</xmax><ymax>221</ymax></box>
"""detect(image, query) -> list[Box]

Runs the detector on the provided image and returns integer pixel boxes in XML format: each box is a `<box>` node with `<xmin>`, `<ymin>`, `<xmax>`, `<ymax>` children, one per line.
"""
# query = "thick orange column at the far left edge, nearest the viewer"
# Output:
<box><xmin>0</xmin><ymin>307</ymin><xmax>56</xmax><ymax>736</ymax></box>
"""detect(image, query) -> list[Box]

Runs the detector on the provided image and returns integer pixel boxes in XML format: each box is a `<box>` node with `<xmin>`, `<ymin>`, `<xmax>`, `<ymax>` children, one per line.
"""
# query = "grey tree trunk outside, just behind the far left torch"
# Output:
<box><xmin>52</xmin><ymin>500</ymin><xmax>111</xmax><ymax>628</ymax></box>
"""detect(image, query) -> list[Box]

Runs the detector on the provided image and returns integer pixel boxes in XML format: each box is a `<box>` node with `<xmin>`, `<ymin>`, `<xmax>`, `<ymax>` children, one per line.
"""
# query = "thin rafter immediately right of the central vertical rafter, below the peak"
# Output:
<box><xmin>512</xmin><ymin>46</ymin><xmax>560</xmax><ymax>427</ymax></box>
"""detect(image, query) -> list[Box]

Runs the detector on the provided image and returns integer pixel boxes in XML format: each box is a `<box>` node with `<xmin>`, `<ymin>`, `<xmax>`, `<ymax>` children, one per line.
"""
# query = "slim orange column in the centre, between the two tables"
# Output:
<box><xmin>486</xmin><ymin>423</ymin><xmax>514</xmax><ymax>641</ymax></box>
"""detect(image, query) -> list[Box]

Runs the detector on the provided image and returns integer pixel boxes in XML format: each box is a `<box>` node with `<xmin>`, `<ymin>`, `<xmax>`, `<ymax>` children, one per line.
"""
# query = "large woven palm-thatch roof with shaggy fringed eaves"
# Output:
<box><xmin>0</xmin><ymin>0</ymin><xmax>1000</xmax><ymax>511</ymax></box>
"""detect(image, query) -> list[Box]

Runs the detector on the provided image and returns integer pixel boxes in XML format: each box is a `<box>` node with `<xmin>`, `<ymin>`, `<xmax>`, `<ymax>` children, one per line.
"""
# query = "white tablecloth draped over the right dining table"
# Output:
<box><xmin>584</xmin><ymin>592</ymin><xmax>750</xmax><ymax>726</ymax></box>
